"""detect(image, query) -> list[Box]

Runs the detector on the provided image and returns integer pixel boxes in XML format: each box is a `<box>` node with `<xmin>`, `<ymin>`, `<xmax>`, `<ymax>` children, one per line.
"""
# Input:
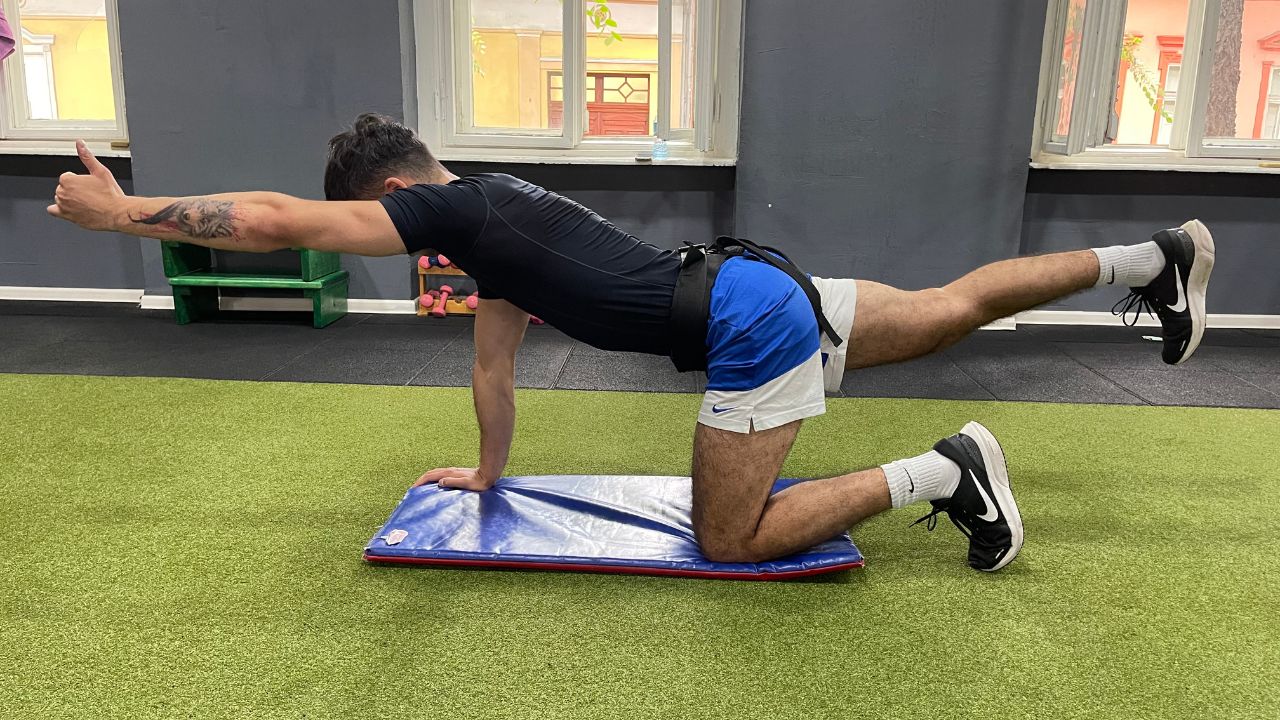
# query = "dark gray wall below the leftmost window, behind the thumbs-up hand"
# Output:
<box><xmin>0</xmin><ymin>155</ymin><xmax>142</xmax><ymax>288</ymax></box>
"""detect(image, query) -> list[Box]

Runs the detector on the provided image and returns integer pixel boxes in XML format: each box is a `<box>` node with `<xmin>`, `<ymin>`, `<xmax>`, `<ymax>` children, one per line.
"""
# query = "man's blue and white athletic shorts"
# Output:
<box><xmin>698</xmin><ymin>258</ymin><xmax>855</xmax><ymax>433</ymax></box>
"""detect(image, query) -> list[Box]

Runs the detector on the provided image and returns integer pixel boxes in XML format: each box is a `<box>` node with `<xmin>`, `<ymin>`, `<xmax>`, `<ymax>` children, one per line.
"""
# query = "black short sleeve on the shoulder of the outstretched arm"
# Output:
<box><xmin>380</xmin><ymin>179</ymin><xmax>489</xmax><ymax>255</ymax></box>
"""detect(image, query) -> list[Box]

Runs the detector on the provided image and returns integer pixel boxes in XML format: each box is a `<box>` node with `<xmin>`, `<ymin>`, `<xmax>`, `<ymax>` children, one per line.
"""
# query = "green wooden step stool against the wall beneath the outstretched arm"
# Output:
<box><xmin>160</xmin><ymin>242</ymin><xmax>348</xmax><ymax>328</ymax></box>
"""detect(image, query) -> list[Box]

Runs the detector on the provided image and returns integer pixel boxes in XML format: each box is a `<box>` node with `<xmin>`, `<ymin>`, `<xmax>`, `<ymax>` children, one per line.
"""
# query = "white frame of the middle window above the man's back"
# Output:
<box><xmin>413</xmin><ymin>0</ymin><xmax>742</xmax><ymax>165</ymax></box>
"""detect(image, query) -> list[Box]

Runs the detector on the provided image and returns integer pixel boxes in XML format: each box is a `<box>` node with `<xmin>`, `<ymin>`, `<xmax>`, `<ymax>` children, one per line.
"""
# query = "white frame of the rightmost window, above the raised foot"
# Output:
<box><xmin>1032</xmin><ymin>0</ymin><xmax>1280</xmax><ymax>173</ymax></box>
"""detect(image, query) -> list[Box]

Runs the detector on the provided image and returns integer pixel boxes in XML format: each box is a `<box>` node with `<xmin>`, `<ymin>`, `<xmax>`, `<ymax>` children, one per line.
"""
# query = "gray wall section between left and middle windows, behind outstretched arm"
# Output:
<box><xmin>120</xmin><ymin>0</ymin><xmax>408</xmax><ymax>297</ymax></box>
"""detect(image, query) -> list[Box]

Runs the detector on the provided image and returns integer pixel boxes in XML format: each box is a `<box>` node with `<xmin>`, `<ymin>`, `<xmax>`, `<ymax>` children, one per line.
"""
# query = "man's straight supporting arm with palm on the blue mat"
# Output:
<box><xmin>415</xmin><ymin>300</ymin><xmax>529</xmax><ymax>491</ymax></box>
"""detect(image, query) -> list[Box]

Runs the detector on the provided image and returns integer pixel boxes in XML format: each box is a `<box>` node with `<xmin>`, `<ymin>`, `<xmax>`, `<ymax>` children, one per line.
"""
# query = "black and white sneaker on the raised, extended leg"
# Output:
<box><xmin>1111</xmin><ymin>220</ymin><xmax>1215</xmax><ymax>365</ymax></box>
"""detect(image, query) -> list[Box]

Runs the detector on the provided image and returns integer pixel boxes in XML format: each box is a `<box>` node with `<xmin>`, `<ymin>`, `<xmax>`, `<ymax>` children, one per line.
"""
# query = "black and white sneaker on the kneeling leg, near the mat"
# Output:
<box><xmin>911</xmin><ymin>423</ymin><xmax>1023</xmax><ymax>573</ymax></box>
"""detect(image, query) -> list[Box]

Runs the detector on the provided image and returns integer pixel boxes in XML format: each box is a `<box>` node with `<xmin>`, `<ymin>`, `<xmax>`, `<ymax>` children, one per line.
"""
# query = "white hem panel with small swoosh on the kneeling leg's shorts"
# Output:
<box><xmin>698</xmin><ymin>351</ymin><xmax>844</xmax><ymax>433</ymax></box>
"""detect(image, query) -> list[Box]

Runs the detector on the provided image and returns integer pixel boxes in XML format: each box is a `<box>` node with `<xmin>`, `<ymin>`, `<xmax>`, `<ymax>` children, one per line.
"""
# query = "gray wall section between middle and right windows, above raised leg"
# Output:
<box><xmin>737</xmin><ymin>0</ymin><xmax>1046</xmax><ymax>288</ymax></box>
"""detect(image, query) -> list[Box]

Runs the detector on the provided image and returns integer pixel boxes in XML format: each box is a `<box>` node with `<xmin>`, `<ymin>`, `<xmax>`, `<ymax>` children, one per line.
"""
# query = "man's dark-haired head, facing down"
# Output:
<box><xmin>324</xmin><ymin>113</ymin><xmax>445</xmax><ymax>200</ymax></box>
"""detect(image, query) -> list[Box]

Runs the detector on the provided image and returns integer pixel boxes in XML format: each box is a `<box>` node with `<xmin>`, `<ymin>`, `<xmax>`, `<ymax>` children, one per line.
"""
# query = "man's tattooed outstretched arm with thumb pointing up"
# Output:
<box><xmin>49</xmin><ymin>143</ymin><xmax>404</xmax><ymax>256</ymax></box>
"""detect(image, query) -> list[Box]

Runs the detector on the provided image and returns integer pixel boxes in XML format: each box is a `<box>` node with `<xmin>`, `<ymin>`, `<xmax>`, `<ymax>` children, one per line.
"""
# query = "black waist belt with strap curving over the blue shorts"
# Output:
<box><xmin>669</xmin><ymin>236</ymin><xmax>845</xmax><ymax>373</ymax></box>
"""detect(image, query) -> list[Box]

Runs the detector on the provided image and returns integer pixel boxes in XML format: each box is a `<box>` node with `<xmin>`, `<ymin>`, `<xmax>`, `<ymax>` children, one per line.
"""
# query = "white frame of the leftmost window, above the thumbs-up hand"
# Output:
<box><xmin>0</xmin><ymin>0</ymin><xmax>128</xmax><ymax>147</ymax></box>
